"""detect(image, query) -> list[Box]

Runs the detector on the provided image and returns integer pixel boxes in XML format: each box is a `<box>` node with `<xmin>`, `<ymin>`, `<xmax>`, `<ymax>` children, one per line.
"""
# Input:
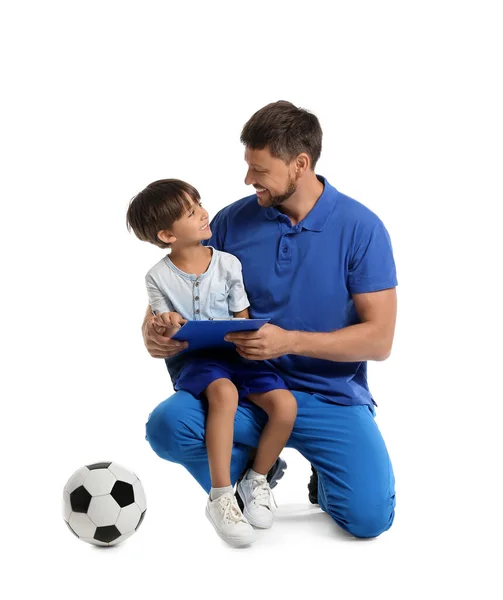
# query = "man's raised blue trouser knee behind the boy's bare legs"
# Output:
<box><xmin>146</xmin><ymin>391</ymin><xmax>267</xmax><ymax>493</ymax></box>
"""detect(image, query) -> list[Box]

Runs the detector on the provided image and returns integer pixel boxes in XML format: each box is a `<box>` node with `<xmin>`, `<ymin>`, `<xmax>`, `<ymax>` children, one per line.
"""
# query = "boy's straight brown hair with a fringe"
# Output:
<box><xmin>126</xmin><ymin>179</ymin><xmax>201</xmax><ymax>248</ymax></box>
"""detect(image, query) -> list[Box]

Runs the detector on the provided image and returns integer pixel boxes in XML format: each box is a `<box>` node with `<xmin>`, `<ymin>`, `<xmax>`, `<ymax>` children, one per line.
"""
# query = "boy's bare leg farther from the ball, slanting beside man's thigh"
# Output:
<box><xmin>248</xmin><ymin>389</ymin><xmax>297</xmax><ymax>475</ymax></box>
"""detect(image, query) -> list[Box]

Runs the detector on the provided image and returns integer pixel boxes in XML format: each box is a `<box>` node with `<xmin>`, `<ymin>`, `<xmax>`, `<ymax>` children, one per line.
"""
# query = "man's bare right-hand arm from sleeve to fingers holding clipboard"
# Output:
<box><xmin>225</xmin><ymin>288</ymin><xmax>397</xmax><ymax>362</ymax></box>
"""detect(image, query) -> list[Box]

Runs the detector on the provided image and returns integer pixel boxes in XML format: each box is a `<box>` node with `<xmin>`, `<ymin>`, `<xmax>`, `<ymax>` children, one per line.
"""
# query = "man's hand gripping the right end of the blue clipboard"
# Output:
<box><xmin>225</xmin><ymin>323</ymin><xmax>295</xmax><ymax>360</ymax></box>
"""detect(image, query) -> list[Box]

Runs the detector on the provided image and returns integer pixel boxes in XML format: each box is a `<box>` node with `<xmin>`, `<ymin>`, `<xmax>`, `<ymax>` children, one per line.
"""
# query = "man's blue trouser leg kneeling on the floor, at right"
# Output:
<box><xmin>288</xmin><ymin>392</ymin><xmax>395</xmax><ymax>538</ymax></box>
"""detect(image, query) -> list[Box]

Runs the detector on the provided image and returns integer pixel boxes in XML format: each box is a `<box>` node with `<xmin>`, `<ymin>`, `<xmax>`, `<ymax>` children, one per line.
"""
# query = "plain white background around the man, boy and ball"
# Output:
<box><xmin>0</xmin><ymin>0</ymin><xmax>503</xmax><ymax>600</ymax></box>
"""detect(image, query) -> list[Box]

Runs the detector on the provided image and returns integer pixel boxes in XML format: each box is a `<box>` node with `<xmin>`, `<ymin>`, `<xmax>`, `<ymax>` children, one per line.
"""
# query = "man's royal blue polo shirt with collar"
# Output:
<box><xmin>205</xmin><ymin>176</ymin><xmax>397</xmax><ymax>404</ymax></box>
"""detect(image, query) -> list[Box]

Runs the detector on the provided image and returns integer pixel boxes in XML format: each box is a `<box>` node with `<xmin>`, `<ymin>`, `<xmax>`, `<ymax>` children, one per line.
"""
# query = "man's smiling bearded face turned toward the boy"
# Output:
<box><xmin>245</xmin><ymin>148</ymin><xmax>297</xmax><ymax>208</ymax></box>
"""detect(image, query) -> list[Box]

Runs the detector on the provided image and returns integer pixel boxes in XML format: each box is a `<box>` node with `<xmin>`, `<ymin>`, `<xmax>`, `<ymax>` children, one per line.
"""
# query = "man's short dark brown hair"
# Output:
<box><xmin>241</xmin><ymin>100</ymin><xmax>323</xmax><ymax>170</ymax></box>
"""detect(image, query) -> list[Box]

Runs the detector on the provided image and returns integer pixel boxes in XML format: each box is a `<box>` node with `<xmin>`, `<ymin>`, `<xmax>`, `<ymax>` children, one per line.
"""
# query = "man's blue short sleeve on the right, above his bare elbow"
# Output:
<box><xmin>348</xmin><ymin>221</ymin><xmax>398</xmax><ymax>294</ymax></box>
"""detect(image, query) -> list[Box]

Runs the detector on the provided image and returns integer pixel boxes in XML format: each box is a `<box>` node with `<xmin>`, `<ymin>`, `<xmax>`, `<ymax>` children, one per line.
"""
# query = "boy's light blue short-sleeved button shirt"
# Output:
<box><xmin>145</xmin><ymin>246</ymin><xmax>250</xmax><ymax>321</ymax></box>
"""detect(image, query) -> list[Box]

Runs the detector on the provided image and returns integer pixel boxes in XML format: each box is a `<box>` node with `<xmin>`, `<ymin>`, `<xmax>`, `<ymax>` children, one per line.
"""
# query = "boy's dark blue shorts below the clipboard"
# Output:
<box><xmin>175</xmin><ymin>356</ymin><xmax>288</xmax><ymax>400</ymax></box>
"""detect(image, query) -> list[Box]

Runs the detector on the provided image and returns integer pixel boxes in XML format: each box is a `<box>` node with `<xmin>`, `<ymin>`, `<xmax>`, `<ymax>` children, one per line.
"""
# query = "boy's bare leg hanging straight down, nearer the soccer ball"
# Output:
<box><xmin>204</xmin><ymin>379</ymin><xmax>238</xmax><ymax>488</ymax></box>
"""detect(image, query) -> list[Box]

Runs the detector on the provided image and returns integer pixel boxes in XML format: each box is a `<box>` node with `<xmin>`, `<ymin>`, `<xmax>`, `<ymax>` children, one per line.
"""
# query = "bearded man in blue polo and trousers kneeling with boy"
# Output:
<box><xmin>143</xmin><ymin>101</ymin><xmax>397</xmax><ymax>538</ymax></box>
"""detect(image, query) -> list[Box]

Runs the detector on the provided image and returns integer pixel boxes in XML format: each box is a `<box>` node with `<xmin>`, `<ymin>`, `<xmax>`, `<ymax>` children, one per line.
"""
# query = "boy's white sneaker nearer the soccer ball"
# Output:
<box><xmin>206</xmin><ymin>493</ymin><xmax>255</xmax><ymax>548</ymax></box>
